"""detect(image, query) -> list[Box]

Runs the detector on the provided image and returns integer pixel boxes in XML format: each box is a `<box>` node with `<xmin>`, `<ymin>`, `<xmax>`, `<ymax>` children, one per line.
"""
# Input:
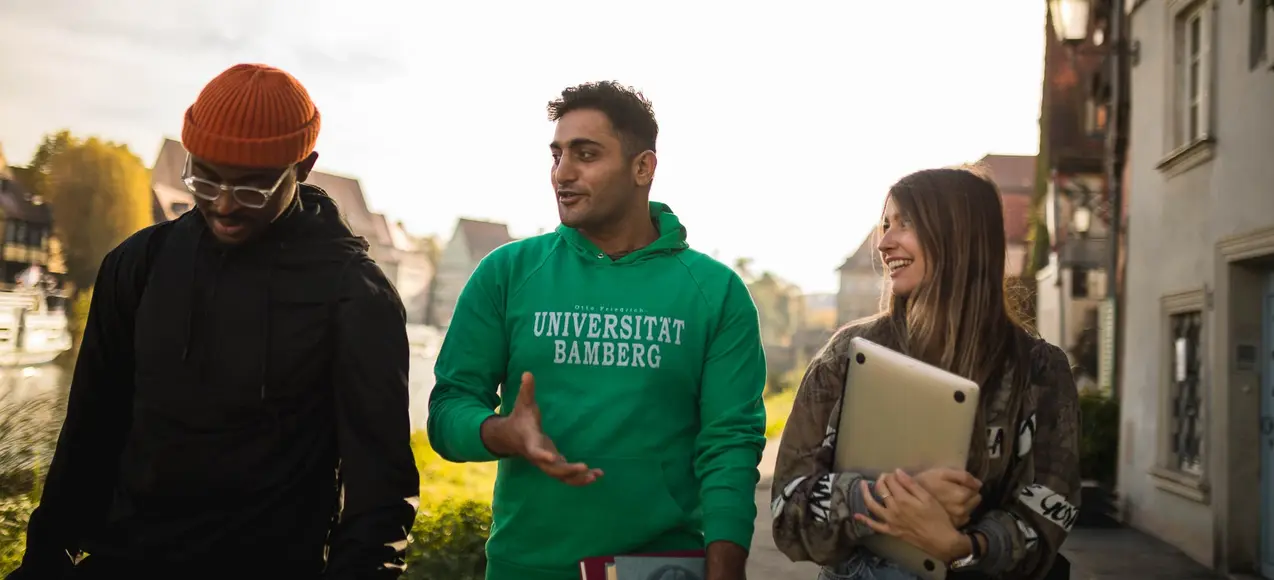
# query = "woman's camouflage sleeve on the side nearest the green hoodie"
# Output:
<box><xmin>771</xmin><ymin>330</ymin><xmax>874</xmax><ymax>566</ymax></box>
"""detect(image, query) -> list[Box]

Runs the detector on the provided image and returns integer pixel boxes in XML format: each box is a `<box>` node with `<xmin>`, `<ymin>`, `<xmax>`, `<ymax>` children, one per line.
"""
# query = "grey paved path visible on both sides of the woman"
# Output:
<box><xmin>748</xmin><ymin>440</ymin><xmax>1226</xmax><ymax>580</ymax></box>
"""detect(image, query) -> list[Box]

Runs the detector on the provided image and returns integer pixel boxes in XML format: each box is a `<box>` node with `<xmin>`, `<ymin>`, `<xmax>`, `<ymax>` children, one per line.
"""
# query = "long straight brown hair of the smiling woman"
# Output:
<box><xmin>871</xmin><ymin>168</ymin><xmax>1026</xmax><ymax>477</ymax></box>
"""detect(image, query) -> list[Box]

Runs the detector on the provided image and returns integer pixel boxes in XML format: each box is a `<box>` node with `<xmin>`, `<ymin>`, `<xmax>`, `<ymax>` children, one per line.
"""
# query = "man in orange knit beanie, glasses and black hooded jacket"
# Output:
<box><xmin>10</xmin><ymin>65</ymin><xmax>419</xmax><ymax>579</ymax></box>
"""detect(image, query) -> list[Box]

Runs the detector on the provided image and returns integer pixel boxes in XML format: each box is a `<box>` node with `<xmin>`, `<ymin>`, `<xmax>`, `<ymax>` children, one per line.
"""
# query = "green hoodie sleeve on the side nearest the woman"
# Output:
<box><xmin>696</xmin><ymin>277</ymin><xmax>766</xmax><ymax>549</ymax></box>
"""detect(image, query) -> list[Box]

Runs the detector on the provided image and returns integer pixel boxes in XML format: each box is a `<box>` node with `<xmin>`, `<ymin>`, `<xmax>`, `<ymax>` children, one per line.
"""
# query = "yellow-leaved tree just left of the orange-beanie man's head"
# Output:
<box><xmin>20</xmin><ymin>130</ymin><xmax>152</xmax><ymax>288</ymax></box>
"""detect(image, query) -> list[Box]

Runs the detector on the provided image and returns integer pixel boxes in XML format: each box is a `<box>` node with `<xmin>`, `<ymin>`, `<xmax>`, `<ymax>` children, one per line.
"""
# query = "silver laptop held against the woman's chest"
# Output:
<box><xmin>836</xmin><ymin>338</ymin><xmax>978</xmax><ymax>580</ymax></box>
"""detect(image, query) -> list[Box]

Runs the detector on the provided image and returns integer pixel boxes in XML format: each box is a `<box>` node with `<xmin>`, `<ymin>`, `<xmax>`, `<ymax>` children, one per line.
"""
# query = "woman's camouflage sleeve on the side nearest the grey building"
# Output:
<box><xmin>972</xmin><ymin>344</ymin><xmax>1080</xmax><ymax>580</ymax></box>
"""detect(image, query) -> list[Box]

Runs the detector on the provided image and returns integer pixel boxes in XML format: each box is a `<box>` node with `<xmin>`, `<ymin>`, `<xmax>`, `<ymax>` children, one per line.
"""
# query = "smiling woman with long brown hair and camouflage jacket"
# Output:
<box><xmin>772</xmin><ymin>168</ymin><xmax>1080</xmax><ymax>580</ymax></box>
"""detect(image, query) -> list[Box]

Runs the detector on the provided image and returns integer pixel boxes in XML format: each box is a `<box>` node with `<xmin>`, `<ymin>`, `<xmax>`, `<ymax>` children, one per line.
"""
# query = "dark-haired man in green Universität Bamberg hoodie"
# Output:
<box><xmin>428</xmin><ymin>82</ymin><xmax>766</xmax><ymax>580</ymax></box>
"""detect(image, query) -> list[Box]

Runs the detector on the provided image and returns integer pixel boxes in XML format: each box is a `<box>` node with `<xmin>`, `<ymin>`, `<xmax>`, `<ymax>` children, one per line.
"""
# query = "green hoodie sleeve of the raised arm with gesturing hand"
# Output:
<box><xmin>427</xmin><ymin>252</ymin><xmax>508</xmax><ymax>463</ymax></box>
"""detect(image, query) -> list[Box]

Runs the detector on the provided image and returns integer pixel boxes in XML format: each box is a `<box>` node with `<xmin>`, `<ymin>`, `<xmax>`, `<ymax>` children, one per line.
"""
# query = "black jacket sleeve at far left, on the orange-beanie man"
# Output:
<box><xmin>9</xmin><ymin>227</ymin><xmax>157</xmax><ymax>579</ymax></box>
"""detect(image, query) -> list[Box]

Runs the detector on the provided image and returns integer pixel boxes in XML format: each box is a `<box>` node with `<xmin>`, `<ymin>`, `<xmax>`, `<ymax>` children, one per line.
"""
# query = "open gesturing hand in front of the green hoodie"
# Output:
<box><xmin>483</xmin><ymin>372</ymin><xmax>601</xmax><ymax>486</ymax></box>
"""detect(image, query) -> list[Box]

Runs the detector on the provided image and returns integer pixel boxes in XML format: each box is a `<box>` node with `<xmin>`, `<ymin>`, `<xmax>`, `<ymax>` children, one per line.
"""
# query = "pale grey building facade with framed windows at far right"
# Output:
<box><xmin>1119</xmin><ymin>0</ymin><xmax>1274</xmax><ymax>579</ymax></box>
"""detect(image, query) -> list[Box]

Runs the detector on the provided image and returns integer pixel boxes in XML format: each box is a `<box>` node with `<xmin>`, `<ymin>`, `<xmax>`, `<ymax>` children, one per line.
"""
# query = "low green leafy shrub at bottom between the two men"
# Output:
<box><xmin>403</xmin><ymin>500</ymin><xmax>490</xmax><ymax>580</ymax></box>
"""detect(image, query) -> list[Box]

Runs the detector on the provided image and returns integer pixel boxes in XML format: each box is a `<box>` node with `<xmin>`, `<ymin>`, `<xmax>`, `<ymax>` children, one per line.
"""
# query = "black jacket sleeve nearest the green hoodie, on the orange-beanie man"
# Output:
<box><xmin>326</xmin><ymin>259</ymin><xmax>420</xmax><ymax>579</ymax></box>
